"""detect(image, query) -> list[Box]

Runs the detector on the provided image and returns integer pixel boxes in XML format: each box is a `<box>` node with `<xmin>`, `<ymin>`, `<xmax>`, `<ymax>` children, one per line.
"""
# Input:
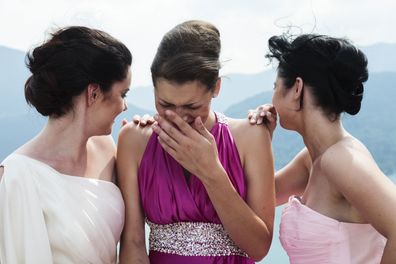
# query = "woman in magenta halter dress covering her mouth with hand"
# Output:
<box><xmin>117</xmin><ymin>21</ymin><xmax>275</xmax><ymax>264</ymax></box>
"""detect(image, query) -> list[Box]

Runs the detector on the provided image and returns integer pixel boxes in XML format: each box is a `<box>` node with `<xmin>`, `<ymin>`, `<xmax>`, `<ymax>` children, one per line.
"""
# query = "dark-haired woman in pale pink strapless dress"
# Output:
<box><xmin>252</xmin><ymin>35</ymin><xmax>396</xmax><ymax>264</ymax></box>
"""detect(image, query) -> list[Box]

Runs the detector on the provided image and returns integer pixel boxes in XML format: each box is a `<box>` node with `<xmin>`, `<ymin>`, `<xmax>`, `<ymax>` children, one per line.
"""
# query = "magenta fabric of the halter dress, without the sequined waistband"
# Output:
<box><xmin>138</xmin><ymin>115</ymin><xmax>254</xmax><ymax>264</ymax></box>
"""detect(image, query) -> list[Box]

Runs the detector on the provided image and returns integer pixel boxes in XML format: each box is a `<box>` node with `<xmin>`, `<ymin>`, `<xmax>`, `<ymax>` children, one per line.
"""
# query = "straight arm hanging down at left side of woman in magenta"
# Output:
<box><xmin>117</xmin><ymin>123</ymin><xmax>149</xmax><ymax>264</ymax></box>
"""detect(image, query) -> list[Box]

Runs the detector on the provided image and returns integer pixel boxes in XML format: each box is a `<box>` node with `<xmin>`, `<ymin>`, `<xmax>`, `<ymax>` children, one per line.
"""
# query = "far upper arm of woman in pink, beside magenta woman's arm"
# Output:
<box><xmin>275</xmin><ymin>148</ymin><xmax>311</xmax><ymax>205</ymax></box>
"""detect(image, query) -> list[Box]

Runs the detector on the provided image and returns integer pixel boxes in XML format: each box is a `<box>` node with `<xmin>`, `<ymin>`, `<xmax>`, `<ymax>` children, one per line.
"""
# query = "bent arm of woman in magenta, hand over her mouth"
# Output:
<box><xmin>153</xmin><ymin>111</ymin><xmax>274</xmax><ymax>260</ymax></box>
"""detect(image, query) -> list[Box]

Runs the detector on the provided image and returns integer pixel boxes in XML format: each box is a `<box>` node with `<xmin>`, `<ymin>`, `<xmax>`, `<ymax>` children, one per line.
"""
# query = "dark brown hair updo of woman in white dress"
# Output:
<box><xmin>25</xmin><ymin>26</ymin><xmax>132</xmax><ymax>117</ymax></box>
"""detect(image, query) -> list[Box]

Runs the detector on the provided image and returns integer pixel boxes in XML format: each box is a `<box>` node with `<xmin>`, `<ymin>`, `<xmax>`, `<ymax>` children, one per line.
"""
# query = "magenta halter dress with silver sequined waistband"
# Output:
<box><xmin>138</xmin><ymin>114</ymin><xmax>254</xmax><ymax>264</ymax></box>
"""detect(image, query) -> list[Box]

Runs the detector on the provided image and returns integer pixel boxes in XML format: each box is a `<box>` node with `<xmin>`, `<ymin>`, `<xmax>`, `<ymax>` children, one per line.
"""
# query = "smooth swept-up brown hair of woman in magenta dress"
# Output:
<box><xmin>151</xmin><ymin>20</ymin><xmax>221</xmax><ymax>91</ymax></box>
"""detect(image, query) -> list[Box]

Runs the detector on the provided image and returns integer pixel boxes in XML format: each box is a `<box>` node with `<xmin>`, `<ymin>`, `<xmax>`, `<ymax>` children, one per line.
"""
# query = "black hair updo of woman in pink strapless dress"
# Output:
<box><xmin>266</xmin><ymin>34</ymin><xmax>368</xmax><ymax>118</ymax></box>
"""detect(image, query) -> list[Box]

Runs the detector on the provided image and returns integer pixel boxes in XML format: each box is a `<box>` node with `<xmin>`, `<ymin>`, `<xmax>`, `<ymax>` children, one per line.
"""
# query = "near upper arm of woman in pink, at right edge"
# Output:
<box><xmin>321</xmin><ymin>144</ymin><xmax>396</xmax><ymax>264</ymax></box>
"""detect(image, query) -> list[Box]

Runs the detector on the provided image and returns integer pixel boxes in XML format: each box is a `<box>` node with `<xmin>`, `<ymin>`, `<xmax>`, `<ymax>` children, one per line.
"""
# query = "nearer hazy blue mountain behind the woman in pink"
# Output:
<box><xmin>225</xmin><ymin>73</ymin><xmax>396</xmax><ymax>174</ymax></box>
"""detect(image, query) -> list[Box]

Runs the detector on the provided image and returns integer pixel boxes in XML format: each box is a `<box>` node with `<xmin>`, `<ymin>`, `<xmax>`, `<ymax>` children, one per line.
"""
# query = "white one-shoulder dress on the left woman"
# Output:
<box><xmin>0</xmin><ymin>153</ymin><xmax>124</xmax><ymax>264</ymax></box>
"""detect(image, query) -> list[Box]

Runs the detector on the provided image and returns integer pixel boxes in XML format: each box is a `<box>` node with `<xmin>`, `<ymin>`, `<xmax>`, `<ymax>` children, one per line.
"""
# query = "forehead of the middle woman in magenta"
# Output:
<box><xmin>154</xmin><ymin>79</ymin><xmax>210</xmax><ymax>105</ymax></box>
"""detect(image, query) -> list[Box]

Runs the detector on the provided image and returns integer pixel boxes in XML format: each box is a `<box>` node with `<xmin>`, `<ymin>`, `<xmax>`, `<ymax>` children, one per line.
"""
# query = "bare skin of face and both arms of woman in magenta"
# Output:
<box><xmin>117</xmin><ymin>79</ymin><xmax>275</xmax><ymax>263</ymax></box>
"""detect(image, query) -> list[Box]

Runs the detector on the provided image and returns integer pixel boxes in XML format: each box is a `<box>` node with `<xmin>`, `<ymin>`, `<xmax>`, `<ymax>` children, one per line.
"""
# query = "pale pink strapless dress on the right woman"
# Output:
<box><xmin>280</xmin><ymin>197</ymin><xmax>386</xmax><ymax>264</ymax></box>
